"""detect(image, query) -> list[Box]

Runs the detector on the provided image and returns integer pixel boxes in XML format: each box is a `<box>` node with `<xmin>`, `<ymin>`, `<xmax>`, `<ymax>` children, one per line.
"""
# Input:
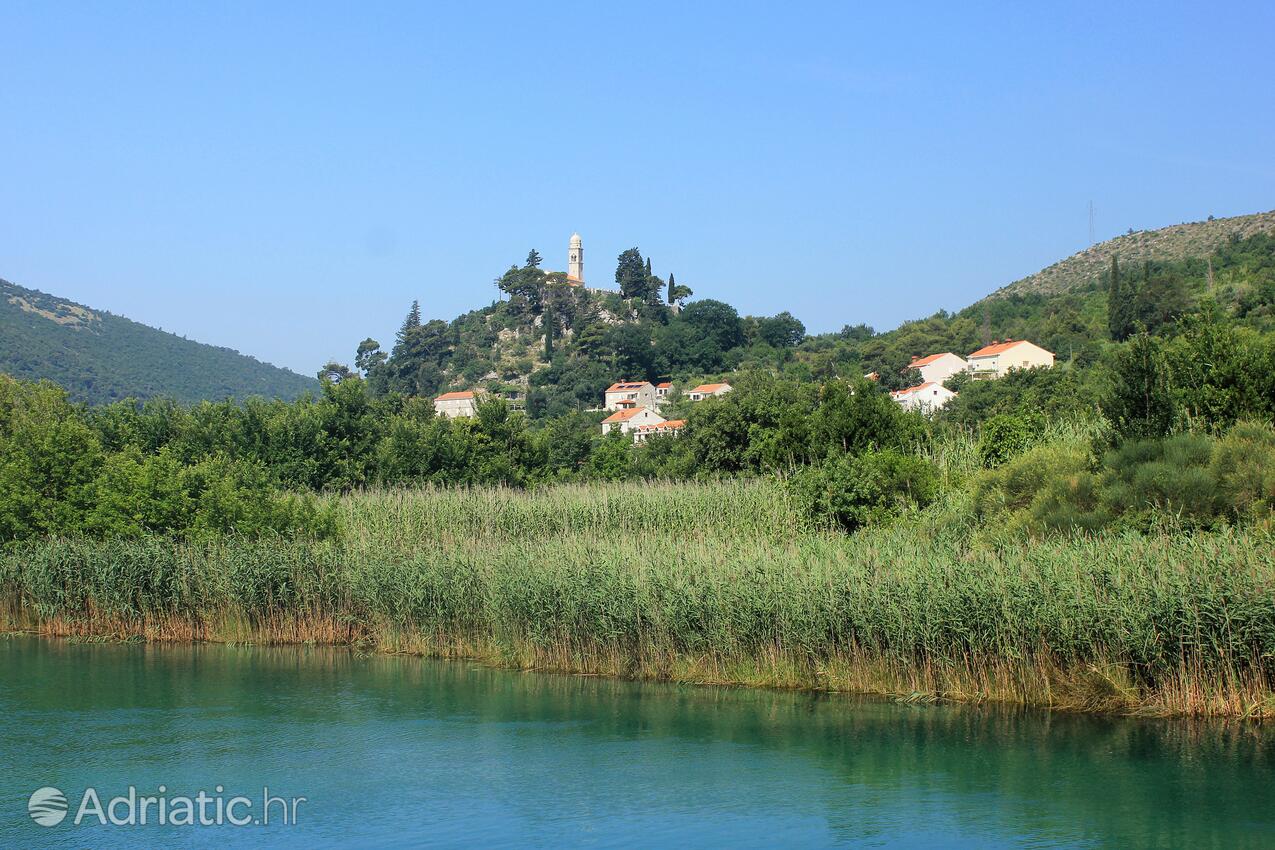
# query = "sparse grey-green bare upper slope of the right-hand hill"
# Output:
<box><xmin>987</xmin><ymin>210</ymin><xmax>1275</xmax><ymax>298</ymax></box>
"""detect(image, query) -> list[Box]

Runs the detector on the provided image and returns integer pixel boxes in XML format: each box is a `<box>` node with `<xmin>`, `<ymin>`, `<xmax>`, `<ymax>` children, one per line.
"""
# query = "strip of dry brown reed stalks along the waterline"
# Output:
<box><xmin>0</xmin><ymin>607</ymin><xmax>1275</xmax><ymax>721</ymax></box>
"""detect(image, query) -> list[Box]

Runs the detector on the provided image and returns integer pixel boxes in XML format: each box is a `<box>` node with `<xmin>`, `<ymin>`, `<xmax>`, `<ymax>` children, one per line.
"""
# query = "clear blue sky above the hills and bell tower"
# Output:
<box><xmin>0</xmin><ymin>0</ymin><xmax>1275</xmax><ymax>373</ymax></box>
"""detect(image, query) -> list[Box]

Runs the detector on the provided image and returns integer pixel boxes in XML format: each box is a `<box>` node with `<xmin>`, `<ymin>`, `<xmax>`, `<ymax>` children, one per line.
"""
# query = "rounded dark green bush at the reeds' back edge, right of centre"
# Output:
<box><xmin>789</xmin><ymin>450</ymin><xmax>938</xmax><ymax>531</ymax></box>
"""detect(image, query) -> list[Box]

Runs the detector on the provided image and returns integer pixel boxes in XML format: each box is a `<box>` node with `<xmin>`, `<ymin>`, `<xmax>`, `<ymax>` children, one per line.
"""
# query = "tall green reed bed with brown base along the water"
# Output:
<box><xmin>0</xmin><ymin>483</ymin><xmax>1275</xmax><ymax>716</ymax></box>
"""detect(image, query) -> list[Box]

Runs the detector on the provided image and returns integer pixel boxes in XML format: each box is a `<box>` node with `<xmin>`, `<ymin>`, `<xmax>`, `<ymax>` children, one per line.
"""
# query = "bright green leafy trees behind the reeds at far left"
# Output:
<box><xmin>0</xmin><ymin>376</ymin><xmax>340</xmax><ymax>542</ymax></box>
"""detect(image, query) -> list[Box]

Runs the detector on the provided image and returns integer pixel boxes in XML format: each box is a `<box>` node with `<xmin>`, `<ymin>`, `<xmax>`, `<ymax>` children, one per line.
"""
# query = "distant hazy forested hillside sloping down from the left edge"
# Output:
<box><xmin>0</xmin><ymin>280</ymin><xmax>319</xmax><ymax>404</ymax></box>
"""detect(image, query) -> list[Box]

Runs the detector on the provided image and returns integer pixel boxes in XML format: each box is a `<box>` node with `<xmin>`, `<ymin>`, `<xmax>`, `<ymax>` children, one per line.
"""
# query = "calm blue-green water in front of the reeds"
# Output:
<box><xmin>0</xmin><ymin>637</ymin><xmax>1275</xmax><ymax>850</ymax></box>
